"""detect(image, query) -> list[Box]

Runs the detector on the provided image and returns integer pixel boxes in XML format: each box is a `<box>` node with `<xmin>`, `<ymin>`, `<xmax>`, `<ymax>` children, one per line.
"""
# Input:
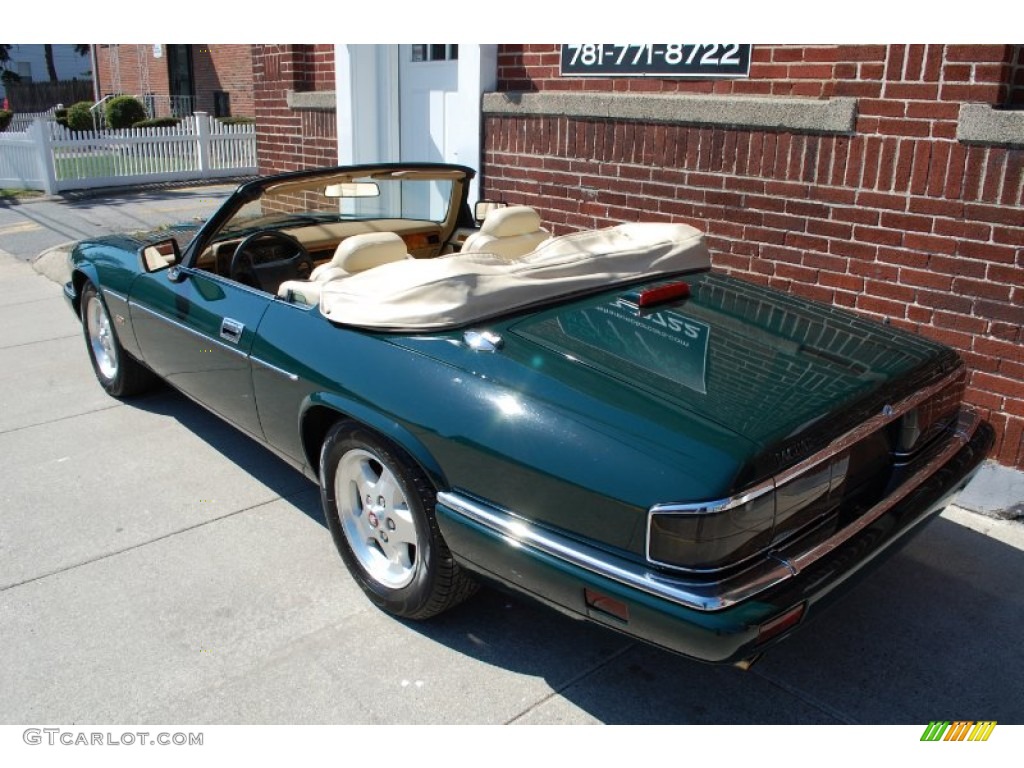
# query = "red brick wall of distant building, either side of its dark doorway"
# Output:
<box><xmin>96</xmin><ymin>44</ymin><xmax>254</xmax><ymax>117</ymax></box>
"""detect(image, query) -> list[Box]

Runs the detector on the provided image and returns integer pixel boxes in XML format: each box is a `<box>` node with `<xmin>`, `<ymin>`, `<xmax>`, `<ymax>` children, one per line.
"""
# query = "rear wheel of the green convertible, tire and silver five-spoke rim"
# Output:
<box><xmin>321</xmin><ymin>422</ymin><xmax>477</xmax><ymax>620</ymax></box>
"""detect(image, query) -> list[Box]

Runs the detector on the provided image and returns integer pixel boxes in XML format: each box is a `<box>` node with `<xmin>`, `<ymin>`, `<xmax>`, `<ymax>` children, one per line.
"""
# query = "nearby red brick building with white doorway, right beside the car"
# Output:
<box><xmin>249</xmin><ymin>44</ymin><xmax>1024</xmax><ymax>475</ymax></box>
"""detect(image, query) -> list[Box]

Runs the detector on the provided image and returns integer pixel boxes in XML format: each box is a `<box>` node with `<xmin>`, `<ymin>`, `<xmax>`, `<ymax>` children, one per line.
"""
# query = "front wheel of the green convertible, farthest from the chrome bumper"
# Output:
<box><xmin>81</xmin><ymin>283</ymin><xmax>156</xmax><ymax>397</ymax></box>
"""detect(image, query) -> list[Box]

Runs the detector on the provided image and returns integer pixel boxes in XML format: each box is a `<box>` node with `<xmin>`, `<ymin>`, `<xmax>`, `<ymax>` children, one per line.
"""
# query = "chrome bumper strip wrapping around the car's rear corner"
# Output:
<box><xmin>437</xmin><ymin>409</ymin><xmax>981</xmax><ymax>611</ymax></box>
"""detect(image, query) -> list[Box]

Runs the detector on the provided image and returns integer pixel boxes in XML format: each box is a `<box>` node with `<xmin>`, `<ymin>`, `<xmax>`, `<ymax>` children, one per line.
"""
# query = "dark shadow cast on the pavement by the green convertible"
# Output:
<box><xmin>112</xmin><ymin>388</ymin><xmax>1024</xmax><ymax>728</ymax></box>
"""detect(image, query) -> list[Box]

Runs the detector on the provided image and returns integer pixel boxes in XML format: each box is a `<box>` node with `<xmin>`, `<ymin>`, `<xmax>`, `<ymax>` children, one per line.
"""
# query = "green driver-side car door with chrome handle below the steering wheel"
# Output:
<box><xmin>129</xmin><ymin>267</ymin><xmax>272</xmax><ymax>439</ymax></box>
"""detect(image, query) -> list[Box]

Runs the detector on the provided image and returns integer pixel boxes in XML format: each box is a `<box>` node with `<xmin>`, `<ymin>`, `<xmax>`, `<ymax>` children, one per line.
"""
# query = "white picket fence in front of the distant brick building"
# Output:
<box><xmin>0</xmin><ymin>113</ymin><xmax>256</xmax><ymax>195</ymax></box>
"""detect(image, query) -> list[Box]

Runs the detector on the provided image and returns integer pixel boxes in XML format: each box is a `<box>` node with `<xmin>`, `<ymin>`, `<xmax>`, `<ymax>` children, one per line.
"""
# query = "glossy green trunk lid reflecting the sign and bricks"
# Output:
<box><xmin>509</xmin><ymin>272</ymin><xmax>957</xmax><ymax>482</ymax></box>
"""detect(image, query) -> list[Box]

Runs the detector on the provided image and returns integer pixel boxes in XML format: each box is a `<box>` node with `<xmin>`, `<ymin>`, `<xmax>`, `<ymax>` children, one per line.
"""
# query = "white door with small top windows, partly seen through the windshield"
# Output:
<box><xmin>398</xmin><ymin>43</ymin><xmax>459</xmax><ymax>218</ymax></box>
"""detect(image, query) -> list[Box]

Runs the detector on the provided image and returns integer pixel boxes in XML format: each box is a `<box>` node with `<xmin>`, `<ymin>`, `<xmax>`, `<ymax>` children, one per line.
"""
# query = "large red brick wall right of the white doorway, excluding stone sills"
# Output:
<box><xmin>482</xmin><ymin>45</ymin><xmax>1024</xmax><ymax>468</ymax></box>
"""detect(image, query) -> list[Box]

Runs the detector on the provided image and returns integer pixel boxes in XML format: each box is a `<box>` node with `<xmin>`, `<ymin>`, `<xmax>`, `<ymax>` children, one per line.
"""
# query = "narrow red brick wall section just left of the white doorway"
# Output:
<box><xmin>253</xmin><ymin>45</ymin><xmax>338</xmax><ymax>185</ymax></box>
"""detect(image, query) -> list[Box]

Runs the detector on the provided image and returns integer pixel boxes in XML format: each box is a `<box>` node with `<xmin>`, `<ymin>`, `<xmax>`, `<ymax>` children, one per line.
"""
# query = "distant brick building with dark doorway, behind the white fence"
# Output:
<box><xmin>92</xmin><ymin>44</ymin><xmax>255</xmax><ymax>117</ymax></box>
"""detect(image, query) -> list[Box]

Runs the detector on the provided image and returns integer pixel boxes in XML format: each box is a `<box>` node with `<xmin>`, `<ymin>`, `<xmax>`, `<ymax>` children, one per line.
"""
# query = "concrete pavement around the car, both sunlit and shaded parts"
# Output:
<box><xmin>0</xmin><ymin>191</ymin><xmax>1024</xmax><ymax>729</ymax></box>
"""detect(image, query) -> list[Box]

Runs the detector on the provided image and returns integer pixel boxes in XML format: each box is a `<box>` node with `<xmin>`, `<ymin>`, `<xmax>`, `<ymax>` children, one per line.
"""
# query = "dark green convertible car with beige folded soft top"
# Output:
<box><xmin>65</xmin><ymin>164</ymin><xmax>992</xmax><ymax>666</ymax></box>
